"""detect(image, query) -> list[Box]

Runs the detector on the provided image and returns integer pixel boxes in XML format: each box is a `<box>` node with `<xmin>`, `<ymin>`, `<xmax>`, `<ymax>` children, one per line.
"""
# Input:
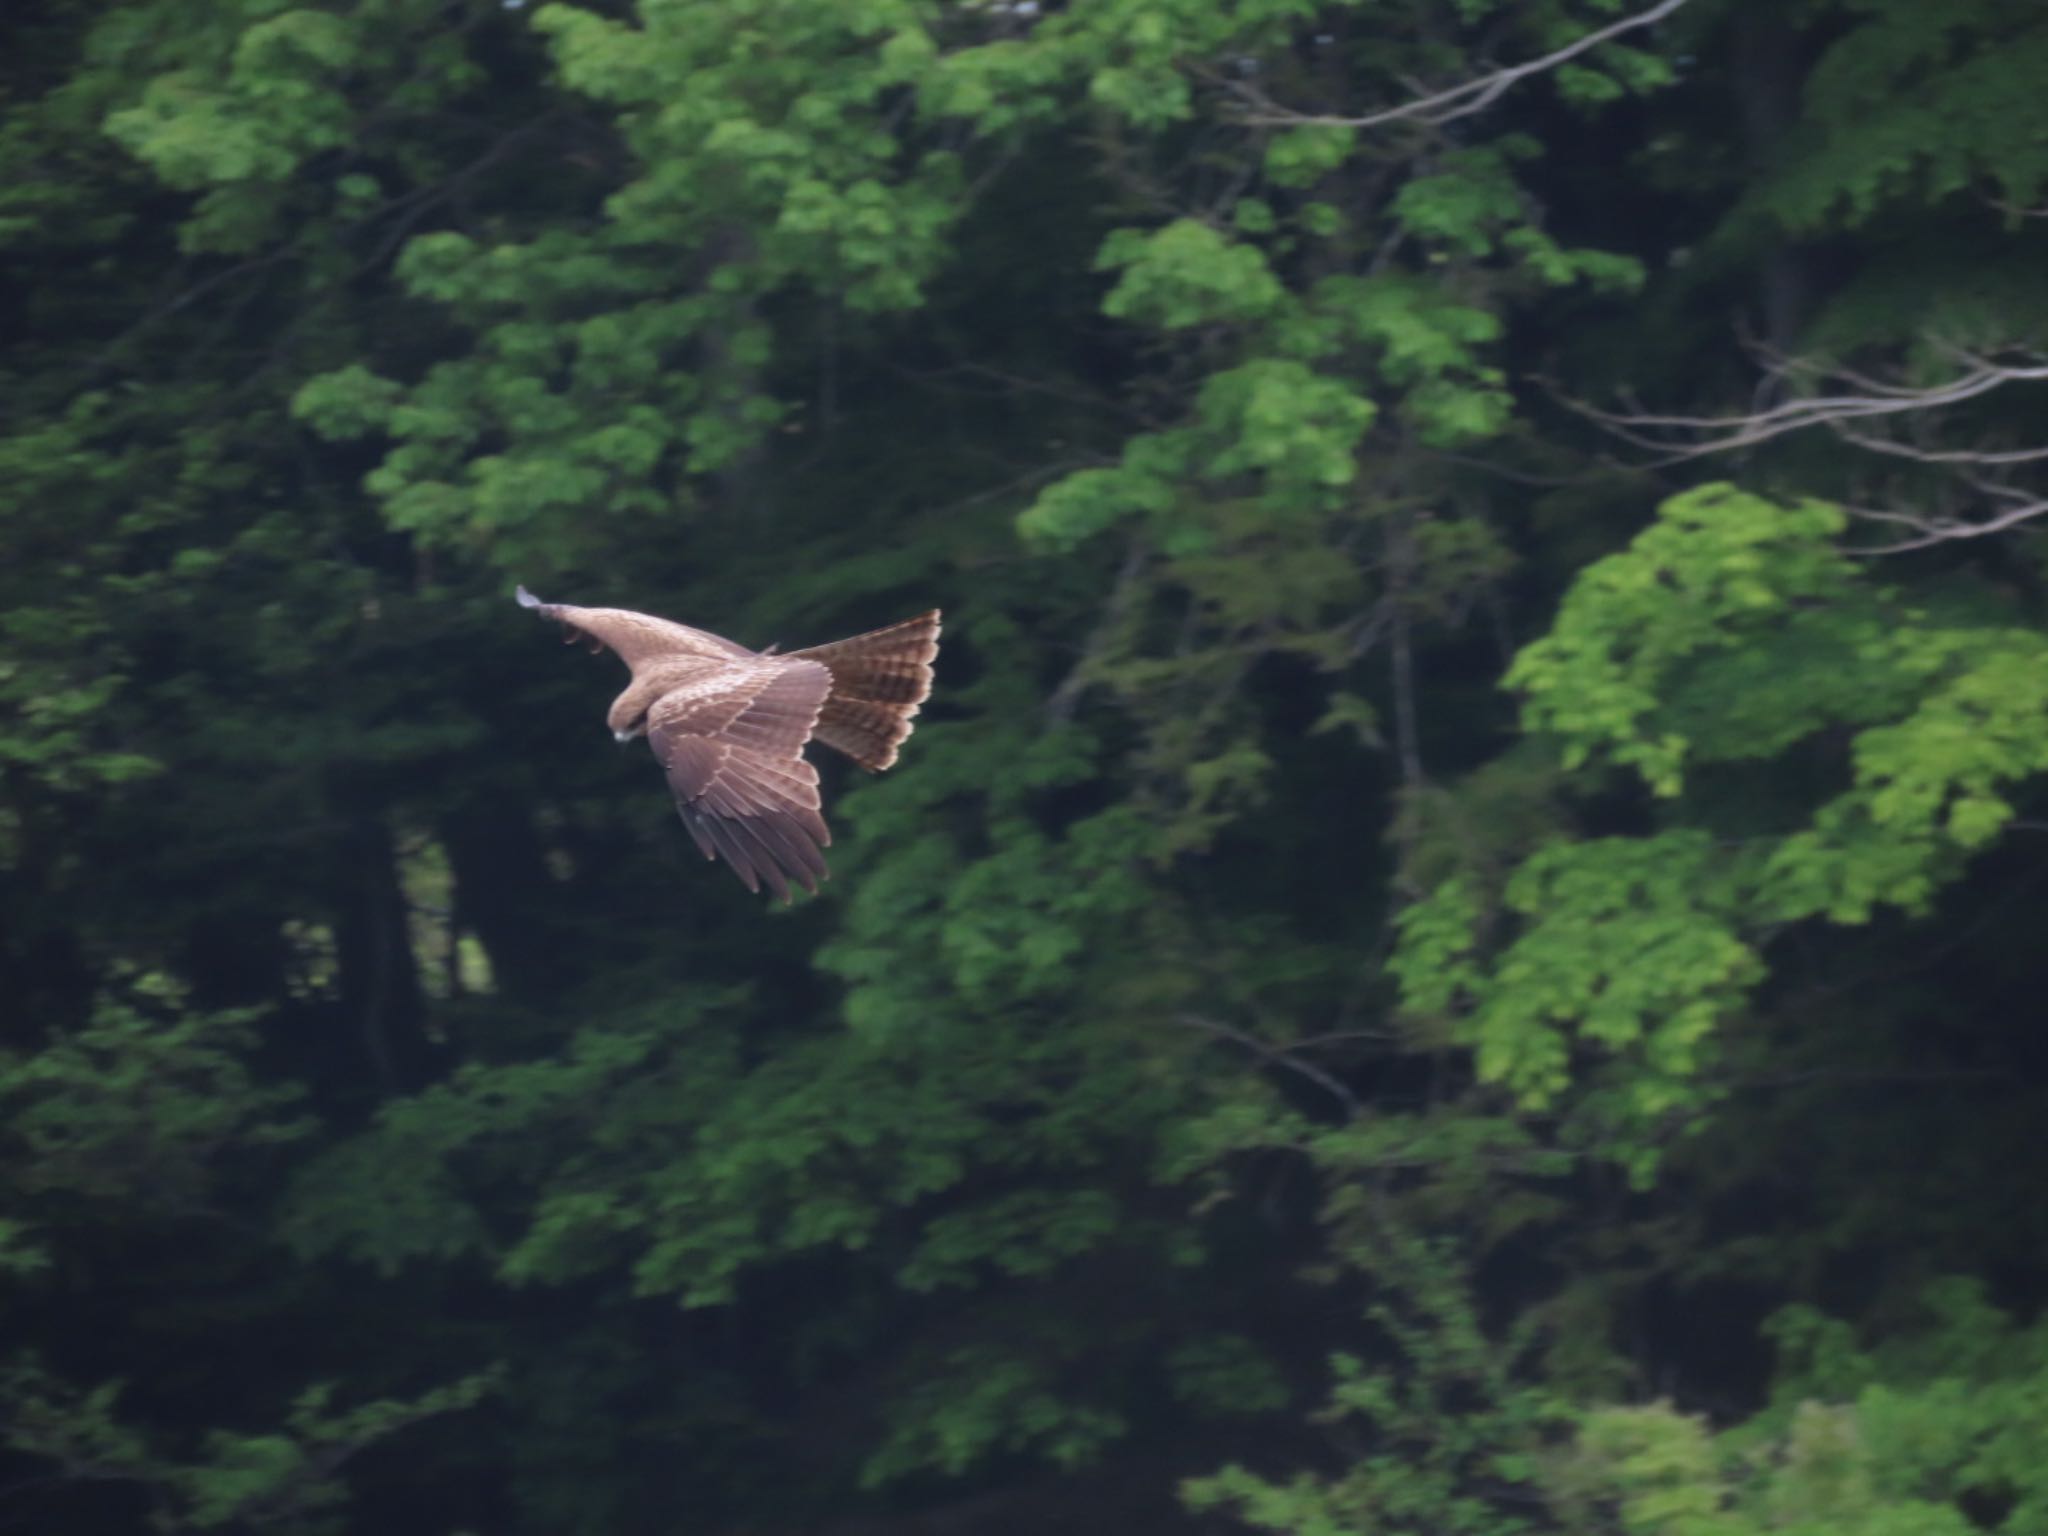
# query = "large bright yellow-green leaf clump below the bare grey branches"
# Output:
<box><xmin>1393</xmin><ymin>485</ymin><xmax>2048</xmax><ymax>1180</ymax></box>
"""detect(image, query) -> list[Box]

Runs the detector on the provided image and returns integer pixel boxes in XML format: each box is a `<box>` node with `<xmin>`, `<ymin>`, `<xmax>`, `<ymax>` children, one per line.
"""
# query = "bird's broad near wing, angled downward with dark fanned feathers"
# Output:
<box><xmin>647</xmin><ymin>657</ymin><xmax>831</xmax><ymax>901</ymax></box>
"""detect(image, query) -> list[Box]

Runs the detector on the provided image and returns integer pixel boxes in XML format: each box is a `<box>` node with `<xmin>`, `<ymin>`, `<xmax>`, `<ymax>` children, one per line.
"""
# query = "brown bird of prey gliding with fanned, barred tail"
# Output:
<box><xmin>516</xmin><ymin>588</ymin><xmax>938</xmax><ymax>901</ymax></box>
